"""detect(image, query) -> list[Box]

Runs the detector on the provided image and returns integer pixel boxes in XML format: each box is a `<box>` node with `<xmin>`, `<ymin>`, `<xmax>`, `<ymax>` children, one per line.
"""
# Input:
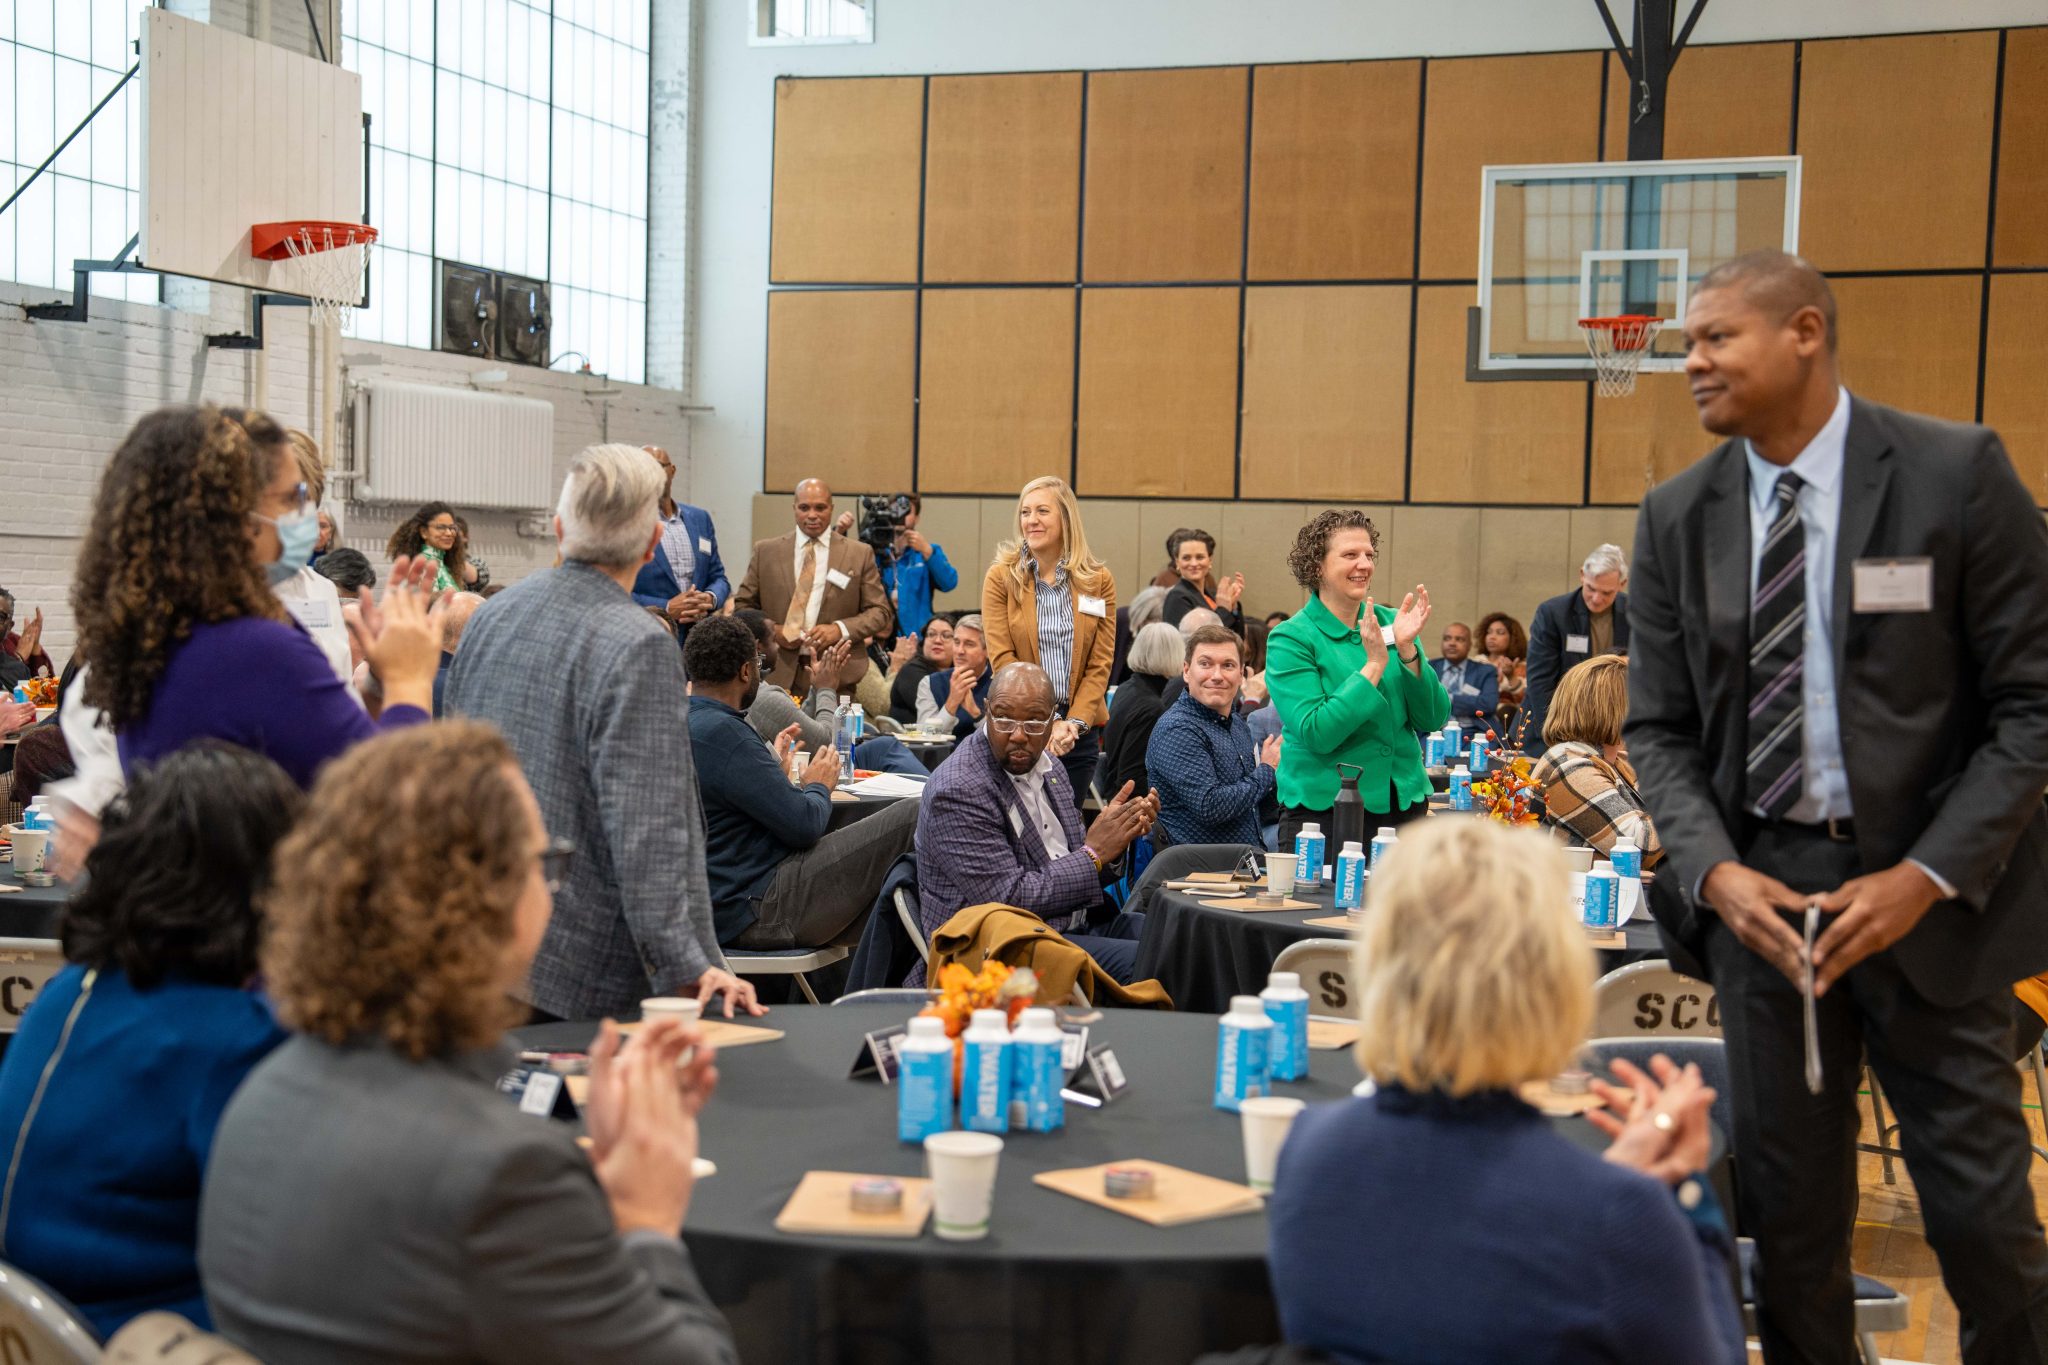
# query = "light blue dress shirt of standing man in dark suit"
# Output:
<box><xmin>1743</xmin><ymin>389</ymin><xmax>1855</xmax><ymax>825</ymax></box>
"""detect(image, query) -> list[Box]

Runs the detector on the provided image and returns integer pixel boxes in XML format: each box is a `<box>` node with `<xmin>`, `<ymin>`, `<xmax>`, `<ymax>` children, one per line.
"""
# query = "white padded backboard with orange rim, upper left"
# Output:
<box><xmin>135</xmin><ymin>8</ymin><xmax>362</xmax><ymax>295</ymax></box>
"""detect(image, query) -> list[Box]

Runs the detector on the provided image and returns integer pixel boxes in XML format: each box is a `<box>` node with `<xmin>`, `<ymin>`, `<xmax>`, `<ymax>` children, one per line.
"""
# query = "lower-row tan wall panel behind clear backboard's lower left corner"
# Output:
<box><xmin>1409</xmin><ymin>284</ymin><xmax>1585</xmax><ymax>503</ymax></box>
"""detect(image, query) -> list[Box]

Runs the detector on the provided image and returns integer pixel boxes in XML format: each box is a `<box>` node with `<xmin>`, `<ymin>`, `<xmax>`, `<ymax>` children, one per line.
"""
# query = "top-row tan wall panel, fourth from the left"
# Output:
<box><xmin>1249</xmin><ymin>61</ymin><xmax>1421</xmax><ymax>280</ymax></box>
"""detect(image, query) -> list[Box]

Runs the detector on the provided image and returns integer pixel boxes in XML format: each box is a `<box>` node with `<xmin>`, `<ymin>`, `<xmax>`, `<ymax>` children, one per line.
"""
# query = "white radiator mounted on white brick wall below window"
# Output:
<box><xmin>350</xmin><ymin>381</ymin><xmax>557</xmax><ymax>510</ymax></box>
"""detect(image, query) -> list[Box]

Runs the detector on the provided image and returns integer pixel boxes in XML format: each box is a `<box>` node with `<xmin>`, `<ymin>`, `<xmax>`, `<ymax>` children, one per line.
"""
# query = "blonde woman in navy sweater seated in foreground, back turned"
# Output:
<box><xmin>1268</xmin><ymin>821</ymin><xmax>1743</xmax><ymax>1365</ymax></box>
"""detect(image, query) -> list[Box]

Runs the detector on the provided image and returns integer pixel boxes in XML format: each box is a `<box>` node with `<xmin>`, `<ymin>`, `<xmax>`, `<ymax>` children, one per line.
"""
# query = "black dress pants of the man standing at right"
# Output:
<box><xmin>1706</xmin><ymin>825</ymin><xmax>2048</xmax><ymax>1365</ymax></box>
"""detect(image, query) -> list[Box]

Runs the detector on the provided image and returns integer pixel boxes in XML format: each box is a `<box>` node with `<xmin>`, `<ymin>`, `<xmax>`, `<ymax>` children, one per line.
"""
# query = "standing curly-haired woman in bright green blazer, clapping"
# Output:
<box><xmin>1266</xmin><ymin>508</ymin><xmax>1450</xmax><ymax>860</ymax></box>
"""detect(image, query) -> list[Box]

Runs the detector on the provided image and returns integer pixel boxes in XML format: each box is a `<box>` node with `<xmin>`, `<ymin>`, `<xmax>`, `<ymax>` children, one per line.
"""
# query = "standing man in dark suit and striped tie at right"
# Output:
<box><xmin>1626</xmin><ymin>252</ymin><xmax>2048</xmax><ymax>1365</ymax></box>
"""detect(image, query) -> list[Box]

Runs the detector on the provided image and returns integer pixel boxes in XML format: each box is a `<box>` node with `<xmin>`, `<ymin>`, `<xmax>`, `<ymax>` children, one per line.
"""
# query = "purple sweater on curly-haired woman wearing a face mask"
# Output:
<box><xmin>119</xmin><ymin>616</ymin><xmax>428</xmax><ymax>788</ymax></box>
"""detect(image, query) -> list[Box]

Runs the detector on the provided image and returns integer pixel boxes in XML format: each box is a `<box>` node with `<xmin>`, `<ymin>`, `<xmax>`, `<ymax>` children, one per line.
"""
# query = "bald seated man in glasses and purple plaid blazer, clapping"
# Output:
<box><xmin>907</xmin><ymin>663</ymin><xmax>1159</xmax><ymax>986</ymax></box>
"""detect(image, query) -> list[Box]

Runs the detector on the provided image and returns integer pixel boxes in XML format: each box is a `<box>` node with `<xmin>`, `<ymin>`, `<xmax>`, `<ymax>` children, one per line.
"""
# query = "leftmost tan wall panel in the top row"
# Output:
<box><xmin>768</xmin><ymin>76</ymin><xmax>924</xmax><ymax>284</ymax></box>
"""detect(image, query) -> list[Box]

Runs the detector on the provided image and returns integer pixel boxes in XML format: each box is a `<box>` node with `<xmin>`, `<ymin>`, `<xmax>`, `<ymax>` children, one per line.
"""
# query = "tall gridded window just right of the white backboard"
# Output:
<box><xmin>342</xmin><ymin>0</ymin><xmax>649</xmax><ymax>383</ymax></box>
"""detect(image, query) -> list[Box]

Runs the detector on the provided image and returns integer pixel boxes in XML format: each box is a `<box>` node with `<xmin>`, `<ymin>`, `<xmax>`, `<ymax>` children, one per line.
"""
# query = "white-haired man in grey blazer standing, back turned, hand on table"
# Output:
<box><xmin>446</xmin><ymin>444</ymin><xmax>762</xmax><ymax>1019</ymax></box>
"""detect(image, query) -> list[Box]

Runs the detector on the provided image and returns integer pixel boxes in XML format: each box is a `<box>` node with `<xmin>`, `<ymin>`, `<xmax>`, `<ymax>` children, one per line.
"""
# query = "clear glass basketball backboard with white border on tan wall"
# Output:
<box><xmin>1468</xmin><ymin>156</ymin><xmax>1800</xmax><ymax>379</ymax></box>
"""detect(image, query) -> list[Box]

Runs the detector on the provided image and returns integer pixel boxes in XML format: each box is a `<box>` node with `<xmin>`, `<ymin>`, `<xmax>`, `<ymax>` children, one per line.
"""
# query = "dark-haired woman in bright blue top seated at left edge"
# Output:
<box><xmin>0</xmin><ymin>743</ymin><xmax>305</xmax><ymax>1336</ymax></box>
